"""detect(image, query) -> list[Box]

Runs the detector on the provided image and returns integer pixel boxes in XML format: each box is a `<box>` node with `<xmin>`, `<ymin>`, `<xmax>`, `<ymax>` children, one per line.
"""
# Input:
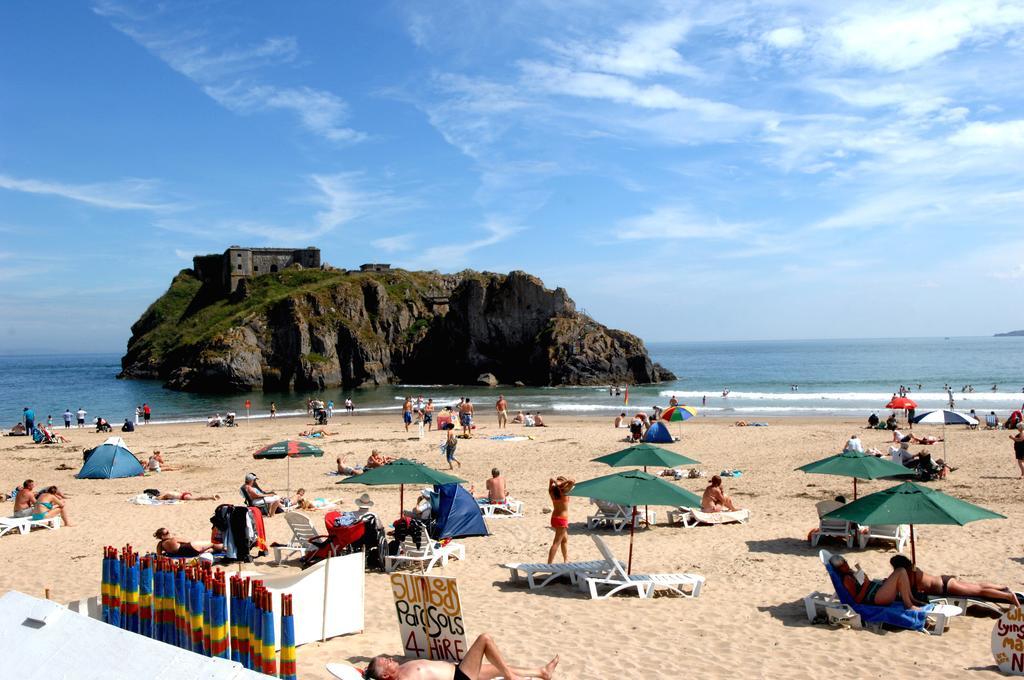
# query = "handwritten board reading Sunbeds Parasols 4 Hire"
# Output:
<box><xmin>391</xmin><ymin>573</ymin><xmax>469</xmax><ymax>664</ymax></box>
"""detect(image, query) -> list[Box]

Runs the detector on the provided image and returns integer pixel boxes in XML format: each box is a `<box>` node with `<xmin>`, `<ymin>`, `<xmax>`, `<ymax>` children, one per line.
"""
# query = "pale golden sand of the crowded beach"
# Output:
<box><xmin>0</xmin><ymin>416</ymin><xmax>1024</xmax><ymax>680</ymax></box>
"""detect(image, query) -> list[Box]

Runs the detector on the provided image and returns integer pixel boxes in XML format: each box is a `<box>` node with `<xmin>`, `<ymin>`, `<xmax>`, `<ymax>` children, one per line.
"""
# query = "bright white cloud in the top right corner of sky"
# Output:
<box><xmin>825</xmin><ymin>0</ymin><xmax>1024</xmax><ymax>72</ymax></box>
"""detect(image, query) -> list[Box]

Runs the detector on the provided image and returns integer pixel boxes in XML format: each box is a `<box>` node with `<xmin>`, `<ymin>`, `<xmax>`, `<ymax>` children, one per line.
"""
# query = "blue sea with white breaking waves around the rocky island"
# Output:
<box><xmin>0</xmin><ymin>337</ymin><xmax>1024</xmax><ymax>429</ymax></box>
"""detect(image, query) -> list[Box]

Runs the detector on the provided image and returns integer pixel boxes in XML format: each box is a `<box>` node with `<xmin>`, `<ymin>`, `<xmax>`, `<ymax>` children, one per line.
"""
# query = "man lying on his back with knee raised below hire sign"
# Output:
<box><xmin>362</xmin><ymin>633</ymin><xmax>558</xmax><ymax>680</ymax></box>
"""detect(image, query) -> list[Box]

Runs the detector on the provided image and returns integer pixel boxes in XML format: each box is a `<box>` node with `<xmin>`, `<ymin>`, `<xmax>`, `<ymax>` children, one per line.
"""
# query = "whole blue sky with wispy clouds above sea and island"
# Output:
<box><xmin>0</xmin><ymin>0</ymin><xmax>1024</xmax><ymax>352</ymax></box>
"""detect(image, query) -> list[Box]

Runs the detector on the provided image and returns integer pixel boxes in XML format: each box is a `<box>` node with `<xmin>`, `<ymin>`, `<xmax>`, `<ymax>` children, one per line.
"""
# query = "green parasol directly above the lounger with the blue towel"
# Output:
<box><xmin>823</xmin><ymin>481</ymin><xmax>1006</xmax><ymax>564</ymax></box>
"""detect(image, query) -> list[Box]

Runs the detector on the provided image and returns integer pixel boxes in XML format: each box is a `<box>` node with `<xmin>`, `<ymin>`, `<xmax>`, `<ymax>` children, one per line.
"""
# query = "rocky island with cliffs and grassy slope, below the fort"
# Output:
<box><xmin>120</xmin><ymin>269</ymin><xmax>675</xmax><ymax>392</ymax></box>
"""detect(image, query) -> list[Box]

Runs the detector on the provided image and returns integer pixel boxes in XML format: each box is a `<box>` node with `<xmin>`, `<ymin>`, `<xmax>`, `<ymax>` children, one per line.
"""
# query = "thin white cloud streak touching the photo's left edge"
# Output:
<box><xmin>0</xmin><ymin>175</ymin><xmax>183</xmax><ymax>212</ymax></box>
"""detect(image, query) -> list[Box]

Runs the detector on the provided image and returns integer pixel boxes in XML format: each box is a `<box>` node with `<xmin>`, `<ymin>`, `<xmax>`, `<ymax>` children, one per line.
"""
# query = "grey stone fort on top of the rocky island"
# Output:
<box><xmin>193</xmin><ymin>246</ymin><xmax>321</xmax><ymax>294</ymax></box>
